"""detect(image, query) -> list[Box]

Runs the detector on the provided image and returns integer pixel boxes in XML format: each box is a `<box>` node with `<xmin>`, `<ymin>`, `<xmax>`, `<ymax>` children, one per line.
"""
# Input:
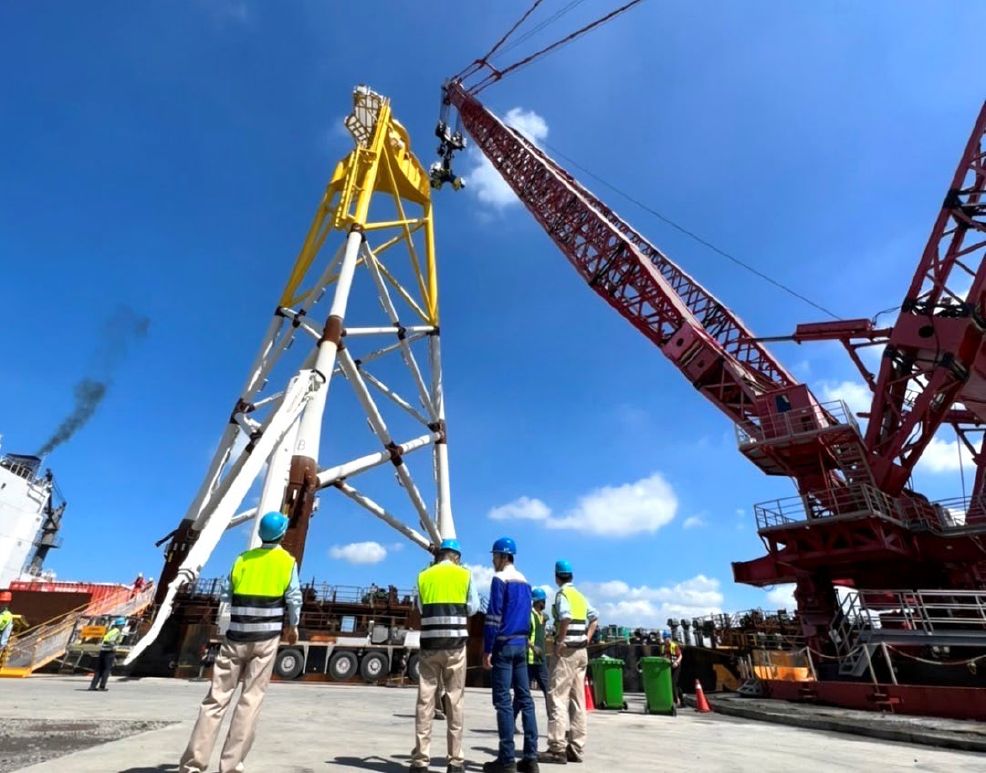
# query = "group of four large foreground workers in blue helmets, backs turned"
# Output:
<box><xmin>162</xmin><ymin>512</ymin><xmax>597</xmax><ymax>773</ymax></box>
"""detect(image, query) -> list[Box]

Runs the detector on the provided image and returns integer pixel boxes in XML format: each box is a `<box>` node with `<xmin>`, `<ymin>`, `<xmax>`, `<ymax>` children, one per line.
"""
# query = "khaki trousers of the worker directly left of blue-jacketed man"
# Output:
<box><xmin>411</xmin><ymin>646</ymin><xmax>466</xmax><ymax>767</ymax></box>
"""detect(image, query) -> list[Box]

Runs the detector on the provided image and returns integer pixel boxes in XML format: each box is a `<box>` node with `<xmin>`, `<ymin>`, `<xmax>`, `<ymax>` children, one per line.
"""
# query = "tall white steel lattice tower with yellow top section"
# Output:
<box><xmin>127</xmin><ymin>86</ymin><xmax>455</xmax><ymax>663</ymax></box>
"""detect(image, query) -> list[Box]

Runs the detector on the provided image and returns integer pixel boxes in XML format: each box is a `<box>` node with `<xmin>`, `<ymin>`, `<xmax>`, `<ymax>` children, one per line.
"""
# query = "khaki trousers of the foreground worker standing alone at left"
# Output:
<box><xmin>179</xmin><ymin>636</ymin><xmax>281</xmax><ymax>773</ymax></box>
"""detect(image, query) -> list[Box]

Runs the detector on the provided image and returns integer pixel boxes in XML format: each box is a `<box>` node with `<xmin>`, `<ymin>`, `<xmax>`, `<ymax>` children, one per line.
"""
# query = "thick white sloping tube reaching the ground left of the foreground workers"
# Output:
<box><xmin>124</xmin><ymin>370</ymin><xmax>316</xmax><ymax>665</ymax></box>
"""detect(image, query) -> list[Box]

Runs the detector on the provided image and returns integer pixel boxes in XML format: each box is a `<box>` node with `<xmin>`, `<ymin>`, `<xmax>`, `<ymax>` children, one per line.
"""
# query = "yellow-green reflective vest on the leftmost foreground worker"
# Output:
<box><xmin>226</xmin><ymin>545</ymin><xmax>294</xmax><ymax>642</ymax></box>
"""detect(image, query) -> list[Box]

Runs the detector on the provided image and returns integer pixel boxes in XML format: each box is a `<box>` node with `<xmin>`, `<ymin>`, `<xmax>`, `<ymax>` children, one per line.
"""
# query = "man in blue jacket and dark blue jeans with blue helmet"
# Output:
<box><xmin>483</xmin><ymin>537</ymin><xmax>538</xmax><ymax>773</ymax></box>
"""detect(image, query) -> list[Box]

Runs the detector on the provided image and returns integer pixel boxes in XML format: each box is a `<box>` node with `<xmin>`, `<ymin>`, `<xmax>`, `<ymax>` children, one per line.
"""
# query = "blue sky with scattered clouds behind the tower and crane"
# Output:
<box><xmin>0</xmin><ymin>0</ymin><xmax>986</xmax><ymax>625</ymax></box>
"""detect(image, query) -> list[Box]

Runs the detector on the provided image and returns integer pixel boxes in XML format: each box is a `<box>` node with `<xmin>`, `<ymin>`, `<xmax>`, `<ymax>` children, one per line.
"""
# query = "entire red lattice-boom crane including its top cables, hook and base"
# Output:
<box><xmin>431</xmin><ymin>2</ymin><xmax>986</xmax><ymax>718</ymax></box>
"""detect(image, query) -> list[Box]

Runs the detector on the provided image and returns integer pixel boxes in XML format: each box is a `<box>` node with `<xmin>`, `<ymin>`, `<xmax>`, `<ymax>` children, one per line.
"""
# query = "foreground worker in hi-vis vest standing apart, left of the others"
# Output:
<box><xmin>179</xmin><ymin>512</ymin><xmax>301</xmax><ymax>773</ymax></box>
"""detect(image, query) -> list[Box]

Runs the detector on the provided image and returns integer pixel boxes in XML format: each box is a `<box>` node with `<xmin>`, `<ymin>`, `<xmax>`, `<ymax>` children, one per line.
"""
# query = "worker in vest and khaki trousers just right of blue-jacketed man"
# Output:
<box><xmin>539</xmin><ymin>560</ymin><xmax>599</xmax><ymax>764</ymax></box>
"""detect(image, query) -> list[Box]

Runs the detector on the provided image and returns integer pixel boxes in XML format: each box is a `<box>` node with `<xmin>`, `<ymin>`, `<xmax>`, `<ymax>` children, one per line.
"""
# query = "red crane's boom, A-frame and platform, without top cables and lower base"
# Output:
<box><xmin>439</xmin><ymin>80</ymin><xmax>986</xmax><ymax>649</ymax></box>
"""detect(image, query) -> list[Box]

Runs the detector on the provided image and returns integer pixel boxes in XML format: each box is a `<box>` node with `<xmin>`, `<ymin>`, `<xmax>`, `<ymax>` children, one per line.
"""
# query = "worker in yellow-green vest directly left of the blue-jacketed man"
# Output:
<box><xmin>411</xmin><ymin>539</ymin><xmax>479</xmax><ymax>773</ymax></box>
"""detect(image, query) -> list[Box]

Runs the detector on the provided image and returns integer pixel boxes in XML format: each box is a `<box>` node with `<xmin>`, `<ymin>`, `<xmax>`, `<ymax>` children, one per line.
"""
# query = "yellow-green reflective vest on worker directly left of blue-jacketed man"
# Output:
<box><xmin>418</xmin><ymin>561</ymin><xmax>472</xmax><ymax>650</ymax></box>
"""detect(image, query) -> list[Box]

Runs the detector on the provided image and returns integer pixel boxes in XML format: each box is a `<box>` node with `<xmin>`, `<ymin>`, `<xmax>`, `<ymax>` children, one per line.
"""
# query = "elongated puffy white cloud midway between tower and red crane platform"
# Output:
<box><xmin>545</xmin><ymin>472</ymin><xmax>678</xmax><ymax>537</ymax></box>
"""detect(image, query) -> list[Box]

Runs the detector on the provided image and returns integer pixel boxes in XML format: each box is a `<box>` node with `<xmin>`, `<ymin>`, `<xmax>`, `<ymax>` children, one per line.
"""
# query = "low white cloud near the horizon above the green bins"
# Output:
<box><xmin>580</xmin><ymin>574</ymin><xmax>723</xmax><ymax>628</ymax></box>
